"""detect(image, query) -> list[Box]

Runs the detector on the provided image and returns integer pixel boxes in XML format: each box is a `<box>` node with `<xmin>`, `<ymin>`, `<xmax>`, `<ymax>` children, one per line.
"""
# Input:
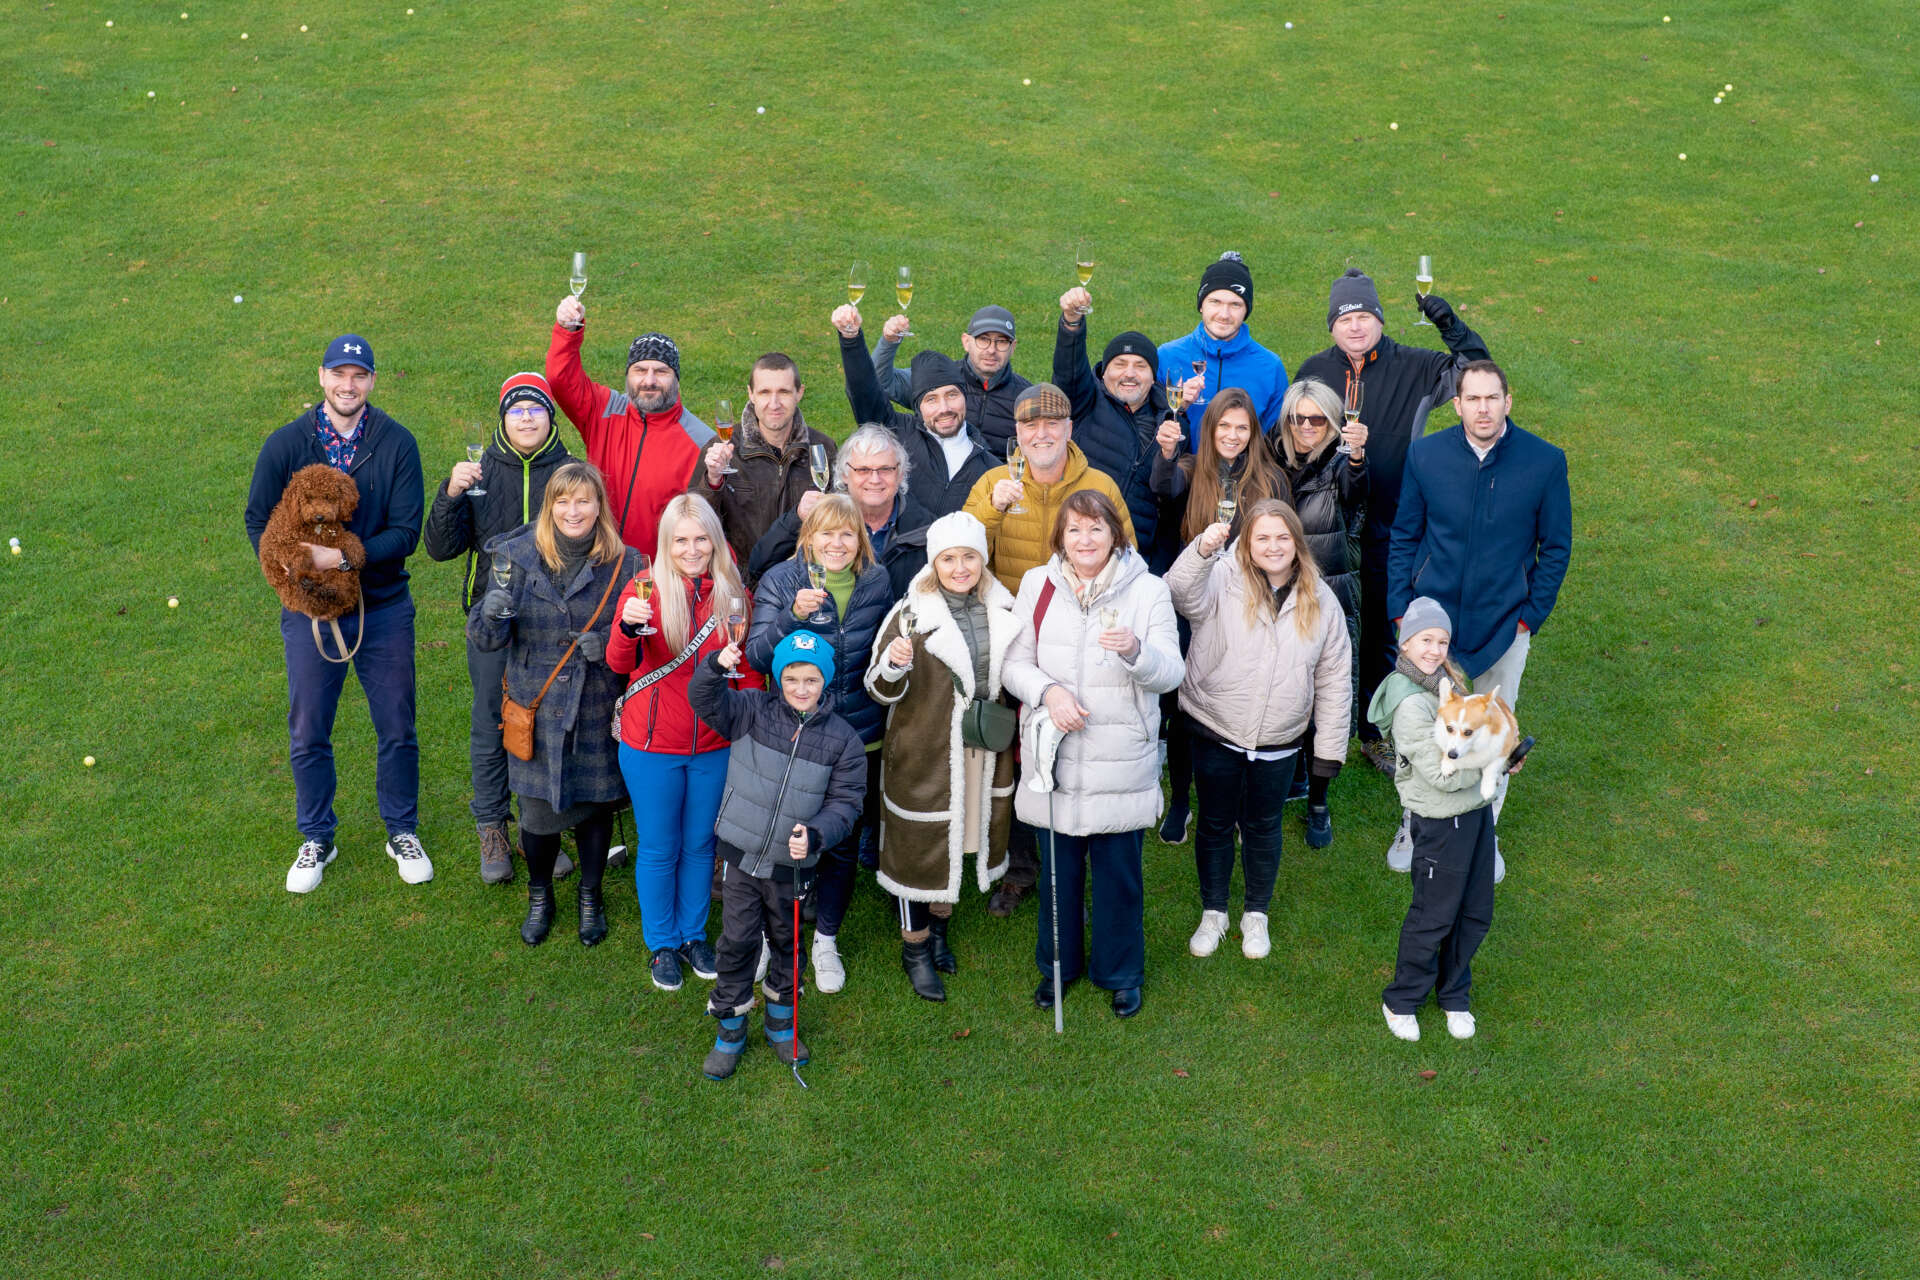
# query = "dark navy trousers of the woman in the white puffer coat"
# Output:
<box><xmin>1033</xmin><ymin>827</ymin><xmax>1146</xmax><ymax>990</ymax></box>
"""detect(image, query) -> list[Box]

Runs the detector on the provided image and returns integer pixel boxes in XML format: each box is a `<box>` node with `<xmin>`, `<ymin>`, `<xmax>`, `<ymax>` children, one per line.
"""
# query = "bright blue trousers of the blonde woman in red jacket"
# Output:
<box><xmin>620</xmin><ymin>743</ymin><xmax>732</xmax><ymax>952</ymax></box>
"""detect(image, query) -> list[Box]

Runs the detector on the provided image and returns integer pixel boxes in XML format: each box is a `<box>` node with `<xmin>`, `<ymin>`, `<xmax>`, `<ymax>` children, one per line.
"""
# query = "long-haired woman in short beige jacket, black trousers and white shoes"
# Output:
<box><xmin>1167</xmin><ymin>499</ymin><xmax>1354</xmax><ymax>960</ymax></box>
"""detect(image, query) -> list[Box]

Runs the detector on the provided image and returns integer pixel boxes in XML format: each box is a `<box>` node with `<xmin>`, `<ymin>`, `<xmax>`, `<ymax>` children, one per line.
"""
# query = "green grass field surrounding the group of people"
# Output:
<box><xmin>0</xmin><ymin>0</ymin><xmax>1920</xmax><ymax>1280</ymax></box>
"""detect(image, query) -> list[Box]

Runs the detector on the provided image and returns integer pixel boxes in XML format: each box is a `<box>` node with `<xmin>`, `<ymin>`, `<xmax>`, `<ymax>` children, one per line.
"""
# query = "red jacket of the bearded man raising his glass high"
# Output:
<box><xmin>547</xmin><ymin>324</ymin><xmax>705</xmax><ymax>555</ymax></box>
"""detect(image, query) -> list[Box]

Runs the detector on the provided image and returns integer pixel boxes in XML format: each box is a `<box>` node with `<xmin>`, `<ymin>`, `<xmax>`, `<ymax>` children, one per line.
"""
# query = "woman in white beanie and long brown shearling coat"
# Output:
<box><xmin>866</xmin><ymin>510</ymin><xmax>1020</xmax><ymax>1000</ymax></box>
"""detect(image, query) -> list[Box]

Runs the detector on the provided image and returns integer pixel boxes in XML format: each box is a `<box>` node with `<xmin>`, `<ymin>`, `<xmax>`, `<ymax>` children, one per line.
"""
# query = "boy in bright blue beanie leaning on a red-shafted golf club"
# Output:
<box><xmin>687</xmin><ymin>631</ymin><xmax>866</xmax><ymax>1080</ymax></box>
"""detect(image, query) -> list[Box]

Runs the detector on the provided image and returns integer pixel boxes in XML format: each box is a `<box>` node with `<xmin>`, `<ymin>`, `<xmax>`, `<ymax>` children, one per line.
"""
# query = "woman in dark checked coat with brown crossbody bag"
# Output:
<box><xmin>467</xmin><ymin>462</ymin><xmax>639</xmax><ymax>946</ymax></box>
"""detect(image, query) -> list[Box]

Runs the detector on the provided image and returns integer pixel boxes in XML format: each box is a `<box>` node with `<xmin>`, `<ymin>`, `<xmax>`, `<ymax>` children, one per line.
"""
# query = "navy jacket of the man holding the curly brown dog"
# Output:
<box><xmin>246</xmin><ymin>405</ymin><xmax>426</xmax><ymax>614</ymax></box>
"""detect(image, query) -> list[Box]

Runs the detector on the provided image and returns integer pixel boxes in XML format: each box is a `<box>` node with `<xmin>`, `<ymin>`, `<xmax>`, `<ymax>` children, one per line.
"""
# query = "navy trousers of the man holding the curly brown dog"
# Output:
<box><xmin>280</xmin><ymin>601</ymin><xmax>420</xmax><ymax>844</ymax></box>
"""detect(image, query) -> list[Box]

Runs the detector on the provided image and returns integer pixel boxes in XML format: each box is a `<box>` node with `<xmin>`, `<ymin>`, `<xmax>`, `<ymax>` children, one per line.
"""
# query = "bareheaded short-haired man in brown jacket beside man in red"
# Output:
<box><xmin>695</xmin><ymin>351</ymin><xmax>835</xmax><ymax>591</ymax></box>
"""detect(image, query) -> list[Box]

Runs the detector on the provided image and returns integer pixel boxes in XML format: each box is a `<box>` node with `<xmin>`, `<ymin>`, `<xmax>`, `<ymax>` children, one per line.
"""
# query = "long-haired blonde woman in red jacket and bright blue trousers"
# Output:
<box><xmin>607</xmin><ymin>493</ymin><xmax>762</xmax><ymax>990</ymax></box>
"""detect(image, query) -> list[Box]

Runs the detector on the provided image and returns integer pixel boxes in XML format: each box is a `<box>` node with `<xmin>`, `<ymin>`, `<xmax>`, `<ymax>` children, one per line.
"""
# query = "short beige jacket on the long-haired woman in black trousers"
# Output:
<box><xmin>1167</xmin><ymin>539</ymin><xmax>1354</xmax><ymax>760</ymax></box>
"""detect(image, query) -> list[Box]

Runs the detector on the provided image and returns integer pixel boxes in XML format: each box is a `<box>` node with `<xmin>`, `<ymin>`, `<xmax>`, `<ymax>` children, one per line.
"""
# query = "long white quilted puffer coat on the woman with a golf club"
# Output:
<box><xmin>1004</xmin><ymin>551</ymin><xmax>1187</xmax><ymax>835</ymax></box>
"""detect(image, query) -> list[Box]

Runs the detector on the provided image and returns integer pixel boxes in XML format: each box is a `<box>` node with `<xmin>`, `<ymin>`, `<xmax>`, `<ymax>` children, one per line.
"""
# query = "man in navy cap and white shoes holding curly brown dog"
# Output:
<box><xmin>246</xmin><ymin>334</ymin><xmax>434</xmax><ymax>892</ymax></box>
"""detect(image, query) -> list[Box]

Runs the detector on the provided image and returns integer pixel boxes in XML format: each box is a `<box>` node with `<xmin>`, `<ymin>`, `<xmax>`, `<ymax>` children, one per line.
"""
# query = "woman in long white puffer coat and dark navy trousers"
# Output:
<box><xmin>1004</xmin><ymin>489</ymin><xmax>1187</xmax><ymax>1017</ymax></box>
